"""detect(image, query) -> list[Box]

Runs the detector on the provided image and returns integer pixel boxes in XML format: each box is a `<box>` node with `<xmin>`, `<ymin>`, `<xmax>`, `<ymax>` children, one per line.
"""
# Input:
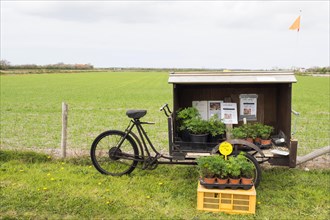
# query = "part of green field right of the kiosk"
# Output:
<box><xmin>292</xmin><ymin>76</ymin><xmax>330</xmax><ymax>155</ymax></box>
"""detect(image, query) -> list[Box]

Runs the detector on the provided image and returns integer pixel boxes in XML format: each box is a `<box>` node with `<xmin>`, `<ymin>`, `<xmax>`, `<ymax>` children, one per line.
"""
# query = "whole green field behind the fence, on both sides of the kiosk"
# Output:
<box><xmin>0</xmin><ymin>72</ymin><xmax>330</xmax><ymax>155</ymax></box>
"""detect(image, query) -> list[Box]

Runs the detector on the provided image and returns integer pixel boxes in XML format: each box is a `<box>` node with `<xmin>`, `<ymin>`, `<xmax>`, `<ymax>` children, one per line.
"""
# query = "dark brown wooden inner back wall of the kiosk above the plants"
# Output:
<box><xmin>173</xmin><ymin>84</ymin><xmax>291</xmax><ymax>137</ymax></box>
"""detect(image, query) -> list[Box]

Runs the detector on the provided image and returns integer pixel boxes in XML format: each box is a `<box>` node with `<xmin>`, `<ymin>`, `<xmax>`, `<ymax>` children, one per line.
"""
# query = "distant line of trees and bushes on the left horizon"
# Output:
<box><xmin>0</xmin><ymin>60</ymin><xmax>94</xmax><ymax>70</ymax></box>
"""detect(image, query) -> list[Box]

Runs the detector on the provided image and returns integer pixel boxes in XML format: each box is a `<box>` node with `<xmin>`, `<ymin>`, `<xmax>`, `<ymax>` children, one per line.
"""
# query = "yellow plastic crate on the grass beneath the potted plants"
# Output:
<box><xmin>197</xmin><ymin>183</ymin><xmax>257</xmax><ymax>214</ymax></box>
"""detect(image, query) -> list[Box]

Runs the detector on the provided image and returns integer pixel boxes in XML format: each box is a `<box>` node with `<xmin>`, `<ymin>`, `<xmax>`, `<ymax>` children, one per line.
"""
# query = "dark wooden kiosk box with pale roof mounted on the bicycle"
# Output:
<box><xmin>168</xmin><ymin>71</ymin><xmax>297</xmax><ymax>167</ymax></box>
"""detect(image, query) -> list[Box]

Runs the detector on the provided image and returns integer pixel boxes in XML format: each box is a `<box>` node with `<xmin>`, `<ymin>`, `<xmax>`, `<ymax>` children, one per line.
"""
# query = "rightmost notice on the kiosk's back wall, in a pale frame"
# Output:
<box><xmin>239</xmin><ymin>94</ymin><xmax>258</xmax><ymax>120</ymax></box>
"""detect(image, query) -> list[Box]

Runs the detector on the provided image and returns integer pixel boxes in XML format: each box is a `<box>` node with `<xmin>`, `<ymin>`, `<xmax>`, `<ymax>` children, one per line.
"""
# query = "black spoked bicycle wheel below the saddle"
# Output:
<box><xmin>91</xmin><ymin>130</ymin><xmax>139</xmax><ymax>176</ymax></box>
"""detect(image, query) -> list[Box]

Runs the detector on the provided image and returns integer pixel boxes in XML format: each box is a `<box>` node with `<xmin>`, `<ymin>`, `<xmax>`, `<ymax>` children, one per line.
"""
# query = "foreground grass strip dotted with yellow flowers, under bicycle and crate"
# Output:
<box><xmin>0</xmin><ymin>150</ymin><xmax>330</xmax><ymax>220</ymax></box>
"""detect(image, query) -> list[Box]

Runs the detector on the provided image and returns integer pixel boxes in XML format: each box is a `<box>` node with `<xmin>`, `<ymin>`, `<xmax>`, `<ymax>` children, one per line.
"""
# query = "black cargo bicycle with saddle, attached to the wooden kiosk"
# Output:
<box><xmin>91</xmin><ymin>104</ymin><xmax>261</xmax><ymax>186</ymax></box>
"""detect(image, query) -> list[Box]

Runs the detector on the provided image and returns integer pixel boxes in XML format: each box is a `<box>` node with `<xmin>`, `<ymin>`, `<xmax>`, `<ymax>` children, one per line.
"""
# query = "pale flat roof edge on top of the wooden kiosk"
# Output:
<box><xmin>168</xmin><ymin>71</ymin><xmax>297</xmax><ymax>84</ymax></box>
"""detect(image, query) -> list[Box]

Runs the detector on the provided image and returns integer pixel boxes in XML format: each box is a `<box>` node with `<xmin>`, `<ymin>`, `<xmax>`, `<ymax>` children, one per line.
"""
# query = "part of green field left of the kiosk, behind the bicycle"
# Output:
<box><xmin>1</xmin><ymin>72</ymin><xmax>171</xmax><ymax>153</ymax></box>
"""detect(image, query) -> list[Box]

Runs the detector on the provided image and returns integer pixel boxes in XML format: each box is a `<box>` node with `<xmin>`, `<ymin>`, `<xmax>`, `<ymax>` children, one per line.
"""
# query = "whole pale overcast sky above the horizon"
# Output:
<box><xmin>1</xmin><ymin>0</ymin><xmax>330</xmax><ymax>69</ymax></box>
